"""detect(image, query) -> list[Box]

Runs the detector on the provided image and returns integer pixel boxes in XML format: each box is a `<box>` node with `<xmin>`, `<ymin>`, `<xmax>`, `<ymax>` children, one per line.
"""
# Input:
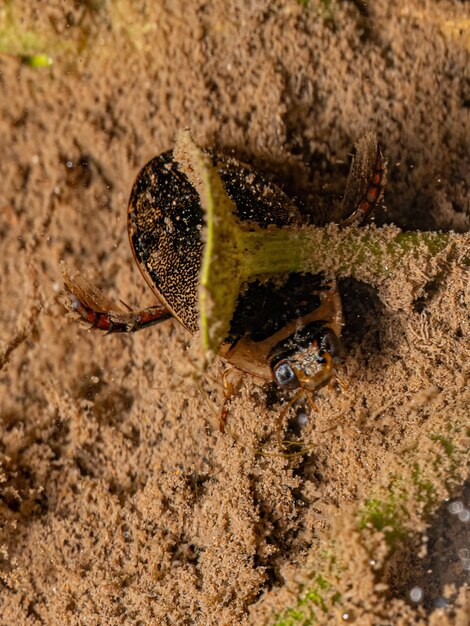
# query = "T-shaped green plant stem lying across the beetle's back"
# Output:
<box><xmin>174</xmin><ymin>131</ymin><xmax>465</xmax><ymax>352</ymax></box>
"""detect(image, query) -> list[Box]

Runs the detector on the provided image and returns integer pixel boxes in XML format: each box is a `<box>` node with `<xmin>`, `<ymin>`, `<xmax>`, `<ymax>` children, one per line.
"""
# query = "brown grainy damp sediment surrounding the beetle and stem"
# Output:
<box><xmin>0</xmin><ymin>0</ymin><xmax>470</xmax><ymax>626</ymax></box>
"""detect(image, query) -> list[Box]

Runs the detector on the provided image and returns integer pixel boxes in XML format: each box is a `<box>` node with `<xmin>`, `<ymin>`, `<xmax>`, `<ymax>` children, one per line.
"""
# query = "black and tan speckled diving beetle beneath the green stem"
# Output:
<box><xmin>62</xmin><ymin>134</ymin><xmax>386</xmax><ymax>430</ymax></box>
